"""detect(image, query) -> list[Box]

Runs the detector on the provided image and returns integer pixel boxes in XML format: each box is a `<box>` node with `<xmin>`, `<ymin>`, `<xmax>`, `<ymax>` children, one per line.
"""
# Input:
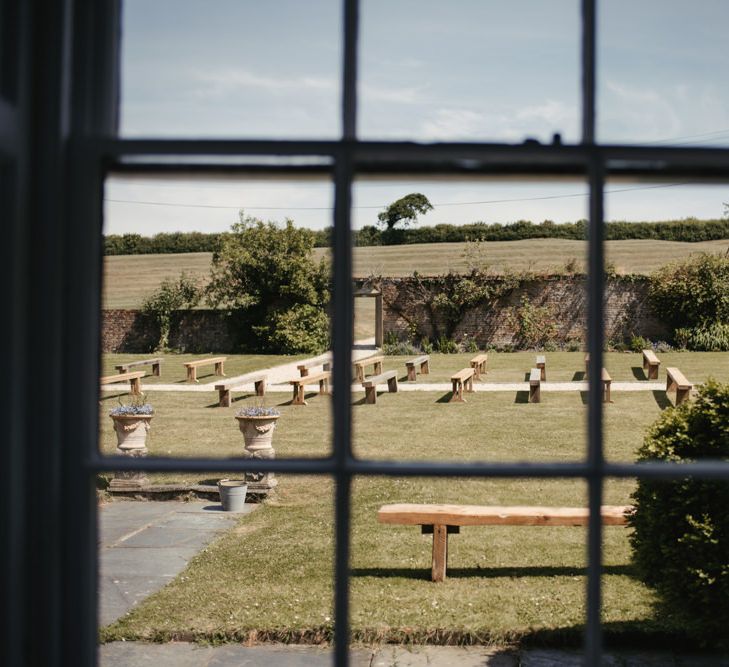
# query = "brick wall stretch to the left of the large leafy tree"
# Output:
<box><xmin>101</xmin><ymin>310</ymin><xmax>233</xmax><ymax>353</ymax></box>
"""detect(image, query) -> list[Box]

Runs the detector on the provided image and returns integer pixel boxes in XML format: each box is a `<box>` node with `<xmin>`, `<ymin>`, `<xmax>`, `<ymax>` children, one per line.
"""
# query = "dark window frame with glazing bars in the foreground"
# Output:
<box><xmin>5</xmin><ymin>0</ymin><xmax>729</xmax><ymax>666</ymax></box>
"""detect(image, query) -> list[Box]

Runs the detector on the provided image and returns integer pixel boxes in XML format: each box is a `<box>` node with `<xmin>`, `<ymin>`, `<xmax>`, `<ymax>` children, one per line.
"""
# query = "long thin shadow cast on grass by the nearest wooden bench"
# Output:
<box><xmin>350</xmin><ymin>565</ymin><xmax>635</xmax><ymax>581</ymax></box>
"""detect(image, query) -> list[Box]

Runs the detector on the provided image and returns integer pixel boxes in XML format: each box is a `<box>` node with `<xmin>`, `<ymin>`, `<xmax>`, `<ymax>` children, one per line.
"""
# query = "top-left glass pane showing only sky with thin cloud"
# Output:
<box><xmin>121</xmin><ymin>0</ymin><xmax>341</xmax><ymax>138</ymax></box>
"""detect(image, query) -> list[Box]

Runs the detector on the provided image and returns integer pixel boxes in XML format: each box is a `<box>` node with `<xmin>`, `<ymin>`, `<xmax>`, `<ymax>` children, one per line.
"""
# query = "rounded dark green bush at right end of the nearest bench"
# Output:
<box><xmin>630</xmin><ymin>379</ymin><xmax>729</xmax><ymax>648</ymax></box>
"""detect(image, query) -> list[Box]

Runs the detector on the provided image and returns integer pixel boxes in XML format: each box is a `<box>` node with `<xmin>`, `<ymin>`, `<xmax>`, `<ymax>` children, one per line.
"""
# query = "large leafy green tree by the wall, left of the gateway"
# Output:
<box><xmin>208</xmin><ymin>211</ymin><xmax>331</xmax><ymax>354</ymax></box>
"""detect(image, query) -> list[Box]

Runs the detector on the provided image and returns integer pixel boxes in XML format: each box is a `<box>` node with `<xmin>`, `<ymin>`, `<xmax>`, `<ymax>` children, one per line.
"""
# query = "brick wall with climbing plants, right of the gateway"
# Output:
<box><xmin>379</xmin><ymin>276</ymin><xmax>668</xmax><ymax>348</ymax></box>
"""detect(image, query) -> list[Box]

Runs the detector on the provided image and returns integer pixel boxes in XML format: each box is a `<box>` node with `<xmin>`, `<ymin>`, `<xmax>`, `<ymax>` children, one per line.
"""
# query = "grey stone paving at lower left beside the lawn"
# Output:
<box><xmin>99</xmin><ymin>501</ymin><xmax>250</xmax><ymax>628</ymax></box>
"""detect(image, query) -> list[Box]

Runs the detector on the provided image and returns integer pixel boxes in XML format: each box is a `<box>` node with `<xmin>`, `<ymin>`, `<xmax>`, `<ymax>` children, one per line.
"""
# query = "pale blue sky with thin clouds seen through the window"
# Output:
<box><xmin>105</xmin><ymin>0</ymin><xmax>729</xmax><ymax>235</ymax></box>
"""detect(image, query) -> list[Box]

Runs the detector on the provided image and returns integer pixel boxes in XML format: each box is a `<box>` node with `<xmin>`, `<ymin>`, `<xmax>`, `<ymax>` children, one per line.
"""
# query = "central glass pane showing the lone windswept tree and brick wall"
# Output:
<box><xmin>352</xmin><ymin>175</ymin><xmax>587</xmax><ymax>461</ymax></box>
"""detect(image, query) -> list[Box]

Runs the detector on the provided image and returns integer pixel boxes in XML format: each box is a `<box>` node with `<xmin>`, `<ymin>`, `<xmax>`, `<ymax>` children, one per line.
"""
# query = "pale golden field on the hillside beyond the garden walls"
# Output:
<box><xmin>104</xmin><ymin>239</ymin><xmax>729</xmax><ymax>308</ymax></box>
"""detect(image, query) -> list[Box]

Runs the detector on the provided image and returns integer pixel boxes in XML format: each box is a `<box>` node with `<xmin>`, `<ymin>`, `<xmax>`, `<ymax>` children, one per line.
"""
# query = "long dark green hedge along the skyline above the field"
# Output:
<box><xmin>104</xmin><ymin>218</ymin><xmax>729</xmax><ymax>255</ymax></box>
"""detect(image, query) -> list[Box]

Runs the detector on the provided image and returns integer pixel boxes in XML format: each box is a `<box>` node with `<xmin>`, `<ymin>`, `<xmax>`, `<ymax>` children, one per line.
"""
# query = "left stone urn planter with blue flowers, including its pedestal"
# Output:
<box><xmin>109</xmin><ymin>396</ymin><xmax>154</xmax><ymax>491</ymax></box>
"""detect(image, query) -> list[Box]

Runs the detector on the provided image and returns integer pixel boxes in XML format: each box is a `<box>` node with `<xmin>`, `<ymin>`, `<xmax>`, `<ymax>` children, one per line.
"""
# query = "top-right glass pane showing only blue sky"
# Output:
<box><xmin>597</xmin><ymin>0</ymin><xmax>729</xmax><ymax>146</ymax></box>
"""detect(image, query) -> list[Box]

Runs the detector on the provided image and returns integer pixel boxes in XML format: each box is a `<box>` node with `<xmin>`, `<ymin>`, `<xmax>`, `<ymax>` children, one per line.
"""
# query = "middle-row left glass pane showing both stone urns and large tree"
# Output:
<box><xmin>99</xmin><ymin>176</ymin><xmax>332</xmax><ymax>474</ymax></box>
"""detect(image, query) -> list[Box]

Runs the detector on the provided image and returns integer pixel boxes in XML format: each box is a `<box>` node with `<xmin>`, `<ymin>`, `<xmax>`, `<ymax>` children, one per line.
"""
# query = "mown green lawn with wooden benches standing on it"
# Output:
<box><xmin>100</xmin><ymin>352</ymin><xmax>728</xmax><ymax>644</ymax></box>
